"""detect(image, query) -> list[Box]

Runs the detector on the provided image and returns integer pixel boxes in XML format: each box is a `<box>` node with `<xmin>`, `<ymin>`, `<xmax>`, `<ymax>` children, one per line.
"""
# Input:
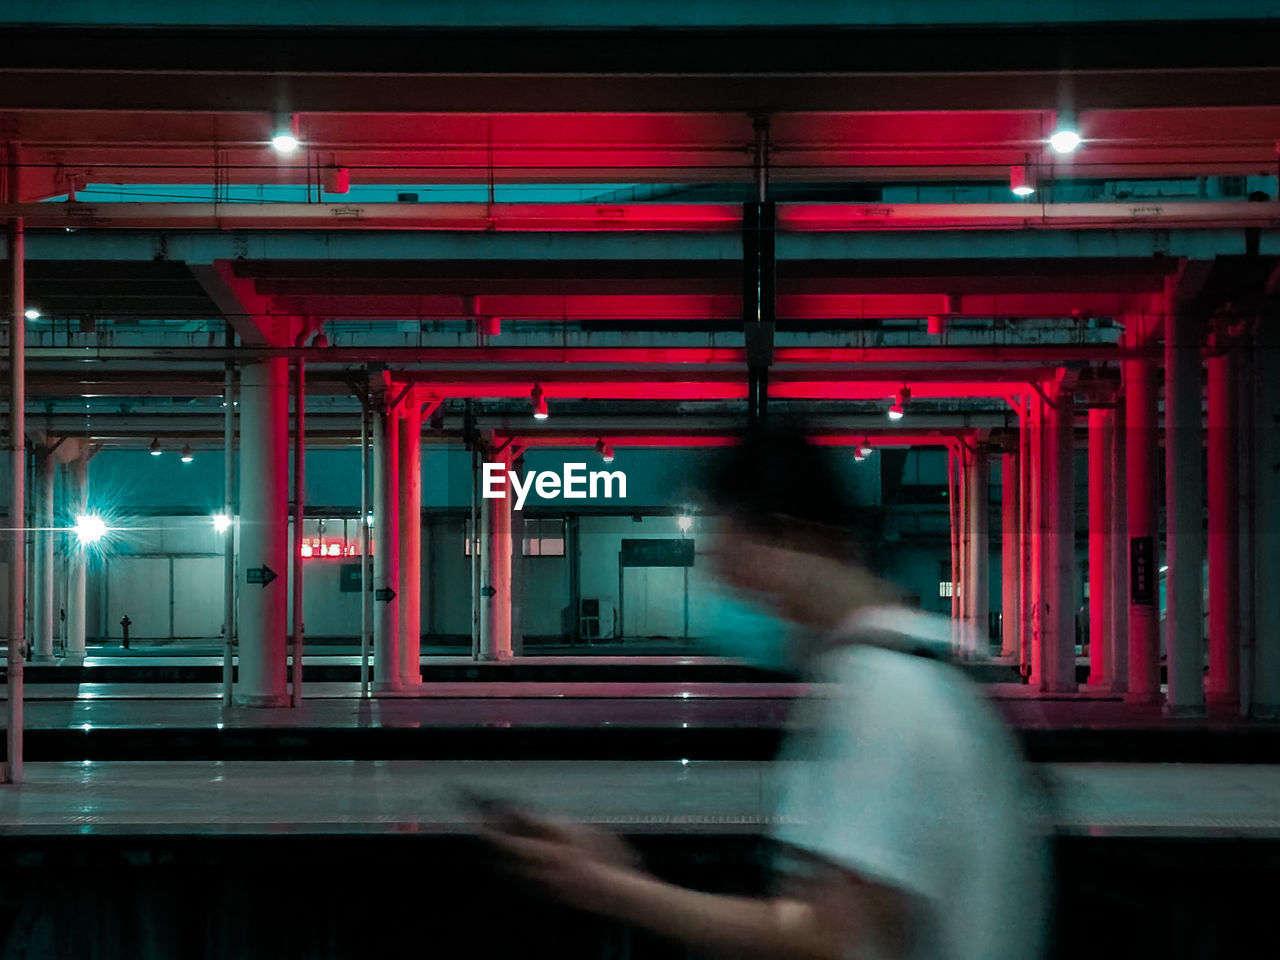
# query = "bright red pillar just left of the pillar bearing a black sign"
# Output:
<box><xmin>1089</xmin><ymin>407</ymin><xmax>1115</xmax><ymax>686</ymax></box>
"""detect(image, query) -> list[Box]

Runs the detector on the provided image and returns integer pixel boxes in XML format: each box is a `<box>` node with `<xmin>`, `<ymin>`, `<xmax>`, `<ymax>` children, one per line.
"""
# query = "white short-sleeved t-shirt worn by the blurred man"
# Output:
<box><xmin>774</xmin><ymin>608</ymin><xmax>1048</xmax><ymax>960</ymax></box>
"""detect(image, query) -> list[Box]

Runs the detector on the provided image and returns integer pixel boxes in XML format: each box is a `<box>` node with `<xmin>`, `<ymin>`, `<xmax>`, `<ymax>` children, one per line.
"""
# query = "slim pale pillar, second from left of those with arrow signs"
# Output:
<box><xmin>374</xmin><ymin>397</ymin><xmax>402</xmax><ymax>692</ymax></box>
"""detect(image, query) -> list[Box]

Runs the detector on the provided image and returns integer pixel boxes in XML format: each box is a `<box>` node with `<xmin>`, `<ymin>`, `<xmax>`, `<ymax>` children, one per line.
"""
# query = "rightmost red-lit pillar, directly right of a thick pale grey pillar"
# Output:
<box><xmin>1206</xmin><ymin>335</ymin><xmax>1240</xmax><ymax>710</ymax></box>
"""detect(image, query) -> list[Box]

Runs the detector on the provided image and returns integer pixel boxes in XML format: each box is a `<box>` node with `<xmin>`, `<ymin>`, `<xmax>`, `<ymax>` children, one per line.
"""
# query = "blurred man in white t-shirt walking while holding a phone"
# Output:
<box><xmin>489</xmin><ymin>430</ymin><xmax>1046</xmax><ymax>960</ymax></box>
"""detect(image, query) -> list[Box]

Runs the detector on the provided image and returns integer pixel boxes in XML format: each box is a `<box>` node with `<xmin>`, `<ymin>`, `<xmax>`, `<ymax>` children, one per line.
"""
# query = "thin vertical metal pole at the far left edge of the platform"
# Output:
<box><xmin>4</xmin><ymin>209</ymin><xmax>27</xmax><ymax>783</ymax></box>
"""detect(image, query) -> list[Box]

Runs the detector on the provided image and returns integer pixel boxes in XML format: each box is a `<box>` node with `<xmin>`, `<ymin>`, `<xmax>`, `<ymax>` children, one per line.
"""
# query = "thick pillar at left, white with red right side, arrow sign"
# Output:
<box><xmin>232</xmin><ymin>357</ymin><xmax>289</xmax><ymax>707</ymax></box>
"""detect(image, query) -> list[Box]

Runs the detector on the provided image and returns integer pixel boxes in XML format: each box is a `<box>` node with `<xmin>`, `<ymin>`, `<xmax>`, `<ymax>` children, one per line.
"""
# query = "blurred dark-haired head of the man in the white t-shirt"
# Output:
<box><xmin>704</xmin><ymin>426</ymin><xmax>878</xmax><ymax>628</ymax></box>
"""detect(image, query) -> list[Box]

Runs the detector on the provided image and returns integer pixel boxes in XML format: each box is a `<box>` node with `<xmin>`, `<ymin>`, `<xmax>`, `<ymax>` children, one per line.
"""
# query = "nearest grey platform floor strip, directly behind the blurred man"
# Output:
<box><xmin>0</xmin><ymin>760</ymin><xmax>1280</xmax><ymax>838</ymax></box>
